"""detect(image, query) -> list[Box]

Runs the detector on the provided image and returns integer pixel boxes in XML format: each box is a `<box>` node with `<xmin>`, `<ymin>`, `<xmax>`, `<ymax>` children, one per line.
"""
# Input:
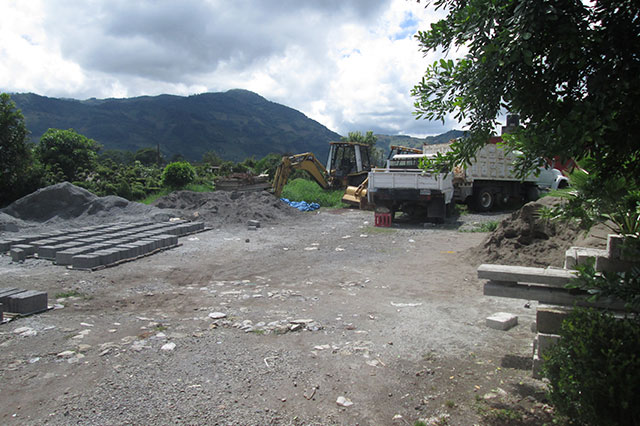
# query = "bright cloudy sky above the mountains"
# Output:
<box><xmin>0</xmin><ymin>0</ymin><xmax>461</xmax><ymax>136</ymax></box>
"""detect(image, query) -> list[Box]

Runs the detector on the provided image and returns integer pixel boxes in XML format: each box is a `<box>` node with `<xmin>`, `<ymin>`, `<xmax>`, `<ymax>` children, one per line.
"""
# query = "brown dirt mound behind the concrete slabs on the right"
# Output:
<box><xmin>472</xmin><ymin>197</ymin><xmax>596</xmax><ymax>267</ymax></box>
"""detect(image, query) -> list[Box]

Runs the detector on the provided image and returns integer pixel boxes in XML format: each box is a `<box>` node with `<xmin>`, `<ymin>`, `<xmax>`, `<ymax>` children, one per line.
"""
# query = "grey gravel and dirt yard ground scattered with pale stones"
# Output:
<box><xmin>0</xmin><ymin>210</ymin><xmax>548</xmax><ymax>425</ymax></box>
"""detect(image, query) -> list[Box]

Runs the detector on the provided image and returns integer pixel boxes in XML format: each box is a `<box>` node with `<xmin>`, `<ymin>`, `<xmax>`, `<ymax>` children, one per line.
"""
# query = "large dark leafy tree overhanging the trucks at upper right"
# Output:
<box><xmin>412</xmin><ymin>0</ymin><xmax>640</xmax><ymax>179</ymax></box>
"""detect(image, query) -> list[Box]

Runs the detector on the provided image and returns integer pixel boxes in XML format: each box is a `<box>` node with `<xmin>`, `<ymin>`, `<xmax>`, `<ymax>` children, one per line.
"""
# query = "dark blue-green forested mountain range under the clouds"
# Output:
<box><xmin>11</xmin><ymin>89</ymin><xmax>462</xmax><ymax>161</ymax></box>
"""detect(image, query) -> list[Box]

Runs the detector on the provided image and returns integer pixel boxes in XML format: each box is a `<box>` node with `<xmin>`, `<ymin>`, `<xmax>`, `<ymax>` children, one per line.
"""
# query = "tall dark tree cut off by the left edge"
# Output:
<box><xmin>0</xmin><ymin>93</ymin><xmax>37</xmax><ymax>206</ymax></box>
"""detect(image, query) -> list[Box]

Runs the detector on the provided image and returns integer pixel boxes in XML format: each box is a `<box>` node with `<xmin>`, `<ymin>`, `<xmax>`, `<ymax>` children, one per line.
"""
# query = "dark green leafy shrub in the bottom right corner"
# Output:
<box><xmin>544</xmin><ymin>309</ymin><xmax>640</xmax><ymax>425</ymax></box>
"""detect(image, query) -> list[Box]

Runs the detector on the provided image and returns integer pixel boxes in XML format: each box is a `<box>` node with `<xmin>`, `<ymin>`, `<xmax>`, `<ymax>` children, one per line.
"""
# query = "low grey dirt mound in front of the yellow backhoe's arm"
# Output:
<box><xmin>153</xmin><ymin>191</ymin><xmax>303</xmax><ymax>226</ymax></box>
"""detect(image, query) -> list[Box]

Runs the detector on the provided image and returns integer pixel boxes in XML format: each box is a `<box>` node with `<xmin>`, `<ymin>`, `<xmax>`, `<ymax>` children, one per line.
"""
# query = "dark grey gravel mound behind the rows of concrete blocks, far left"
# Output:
<box><xmin>0</xmin><ymin>182</ymin><xmax>172</xmax><ymax>230</ymax></box>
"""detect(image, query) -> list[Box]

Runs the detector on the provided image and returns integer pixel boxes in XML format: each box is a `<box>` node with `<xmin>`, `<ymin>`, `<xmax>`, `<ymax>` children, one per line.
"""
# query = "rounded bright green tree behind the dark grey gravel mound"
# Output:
<box><xmin>36</xmin><ymin>129</ymin><xmax>100</xmax><ymax>182</ymax></box>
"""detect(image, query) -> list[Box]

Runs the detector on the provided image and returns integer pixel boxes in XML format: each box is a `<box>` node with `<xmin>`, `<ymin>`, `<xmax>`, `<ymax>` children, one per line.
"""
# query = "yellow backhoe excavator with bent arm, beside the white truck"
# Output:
<box><xmin>272</xmin><ymin>142</ymin><xmax>371</xmax><ymax>206</ymax></box>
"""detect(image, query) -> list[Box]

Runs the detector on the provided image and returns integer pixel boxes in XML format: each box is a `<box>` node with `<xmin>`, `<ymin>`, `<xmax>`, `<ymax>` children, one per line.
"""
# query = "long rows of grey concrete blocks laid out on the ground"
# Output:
<box><xmin>0</xmin><ymin>221</ymin><xmax>204</xmax><ymax>269</ymax></box>
